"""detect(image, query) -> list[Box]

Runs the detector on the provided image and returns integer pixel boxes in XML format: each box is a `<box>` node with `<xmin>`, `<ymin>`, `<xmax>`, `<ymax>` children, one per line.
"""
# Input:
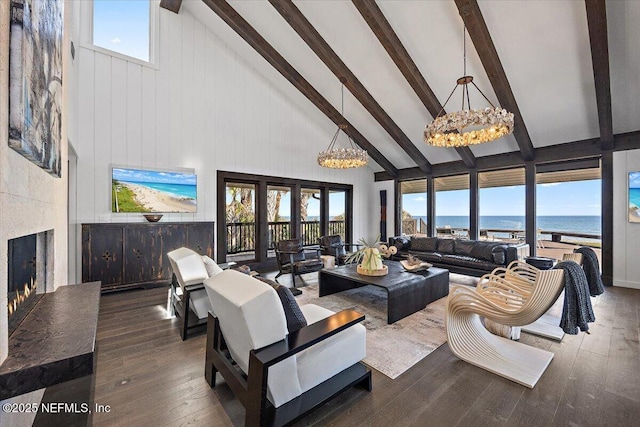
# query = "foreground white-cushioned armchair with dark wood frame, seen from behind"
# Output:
<box><xmin>205</xmin><ymin>270</ymin><xmax>371</xmax><ymax>425</ymax></box>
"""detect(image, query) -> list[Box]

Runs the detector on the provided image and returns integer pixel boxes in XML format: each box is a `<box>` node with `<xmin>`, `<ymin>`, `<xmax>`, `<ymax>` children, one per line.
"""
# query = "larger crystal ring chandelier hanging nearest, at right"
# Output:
<box><xmin>424</xmin><ymin>27</ymin><xmax>513</xmax><ymax>147</ymax></box>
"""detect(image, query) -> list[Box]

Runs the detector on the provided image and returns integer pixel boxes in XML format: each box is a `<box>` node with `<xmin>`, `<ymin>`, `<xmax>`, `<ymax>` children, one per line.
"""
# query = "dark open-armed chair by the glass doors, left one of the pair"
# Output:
<box><xmin>276</xmin><ymin>239</ymin><xmax>324</xmax><ymax>295</ymax></box>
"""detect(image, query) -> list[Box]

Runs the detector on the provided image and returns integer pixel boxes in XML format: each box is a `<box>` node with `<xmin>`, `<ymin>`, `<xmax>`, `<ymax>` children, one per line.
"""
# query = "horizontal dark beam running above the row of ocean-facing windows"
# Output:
<box><xmin>375</xmin><ymin>130</ymin><xmax>640</xmax><ymax>181</ymax></box>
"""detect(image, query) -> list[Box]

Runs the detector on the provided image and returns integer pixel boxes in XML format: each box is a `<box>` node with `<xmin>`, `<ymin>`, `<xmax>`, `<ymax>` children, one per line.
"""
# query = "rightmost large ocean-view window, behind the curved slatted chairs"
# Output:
<box><xmin>536</xmin><ymin>167</ymin><xmax>602</xmax><ymax>254</ymax></box>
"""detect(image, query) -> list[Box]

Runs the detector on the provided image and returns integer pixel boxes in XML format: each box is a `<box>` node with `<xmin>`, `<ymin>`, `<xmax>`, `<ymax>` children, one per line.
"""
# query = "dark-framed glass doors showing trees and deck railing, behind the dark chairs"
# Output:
<box><xmin>216</xmin><ymin>171</ymin><xmax>353</xmax><ymax>263</ymax></box>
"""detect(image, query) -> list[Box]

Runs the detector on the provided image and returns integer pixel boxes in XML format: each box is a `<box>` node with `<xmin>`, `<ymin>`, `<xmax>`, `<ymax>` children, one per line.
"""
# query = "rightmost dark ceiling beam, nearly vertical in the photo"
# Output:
<box><xmin>585</xmin><ymin>0</ymin><xmax>613</xmax><ymax>150</ymax></box>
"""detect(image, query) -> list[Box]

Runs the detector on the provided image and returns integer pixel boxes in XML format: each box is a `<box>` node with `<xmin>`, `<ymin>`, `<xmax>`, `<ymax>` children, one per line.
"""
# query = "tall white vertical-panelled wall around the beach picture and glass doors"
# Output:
<box><xmin>72</xmin><ymin>8</ymin><xmax>379</xmax><ymax>278</ymax></box>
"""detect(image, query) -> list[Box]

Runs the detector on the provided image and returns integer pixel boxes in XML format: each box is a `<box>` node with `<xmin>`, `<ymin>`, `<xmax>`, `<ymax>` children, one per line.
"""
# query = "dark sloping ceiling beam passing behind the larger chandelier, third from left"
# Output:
<box><xmin>352</xmin><ymin>0</ymin><xmax>476</xmax><ymax>169</ymax></box>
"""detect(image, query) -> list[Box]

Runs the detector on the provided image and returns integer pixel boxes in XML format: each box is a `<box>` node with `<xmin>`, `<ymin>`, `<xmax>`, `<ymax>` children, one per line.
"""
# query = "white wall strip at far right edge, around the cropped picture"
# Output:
<box><xmin>613</xmin><ymin>150</ymin><xmax>640</xmax><ymax>289</ymax></box>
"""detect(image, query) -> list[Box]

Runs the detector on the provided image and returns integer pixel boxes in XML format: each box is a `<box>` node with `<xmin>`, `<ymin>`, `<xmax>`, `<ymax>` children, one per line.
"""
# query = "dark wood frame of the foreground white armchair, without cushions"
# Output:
<box><xmin>204</xmin><ymin>310</ymin><xmax>372</xmax><ymax>426</ymax></box>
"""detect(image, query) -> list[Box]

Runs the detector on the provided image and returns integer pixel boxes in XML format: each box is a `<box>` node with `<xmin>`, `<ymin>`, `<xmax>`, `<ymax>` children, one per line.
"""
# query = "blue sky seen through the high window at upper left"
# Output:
<box><xmin>93</xmin><ymin>0</ymin><xmax>149</xmax><ymax>61</ymax></box>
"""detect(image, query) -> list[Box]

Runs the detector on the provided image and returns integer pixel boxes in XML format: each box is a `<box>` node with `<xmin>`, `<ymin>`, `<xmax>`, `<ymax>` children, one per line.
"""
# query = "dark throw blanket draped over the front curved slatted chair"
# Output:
<box><xmin>554</xmin><ymin>261</ymin><xmax>596</xmax><ymax>335</ymax></box>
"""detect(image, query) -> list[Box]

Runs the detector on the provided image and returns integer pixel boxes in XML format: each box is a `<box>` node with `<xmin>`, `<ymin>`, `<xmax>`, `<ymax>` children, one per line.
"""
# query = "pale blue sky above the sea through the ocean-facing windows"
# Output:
<box><xmin>402</xmin><ymin>179</ymin><xmax>604</xmax><ymax>216</ymax></box>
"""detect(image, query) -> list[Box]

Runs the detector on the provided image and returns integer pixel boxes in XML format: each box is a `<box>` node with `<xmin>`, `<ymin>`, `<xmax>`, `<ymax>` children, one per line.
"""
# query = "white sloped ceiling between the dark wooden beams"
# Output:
<box><xmin>182</xmin><ymin>0</ymin><xmax>640</xmax><ymax>171</ymax></box>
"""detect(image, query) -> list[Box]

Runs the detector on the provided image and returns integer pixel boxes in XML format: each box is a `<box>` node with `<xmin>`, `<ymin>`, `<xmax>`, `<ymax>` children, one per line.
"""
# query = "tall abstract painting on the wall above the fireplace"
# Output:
<box><xmin>9</xmin><ymin>0</ymin><xmax>64</xmax><ymax>177</ymax></box>
